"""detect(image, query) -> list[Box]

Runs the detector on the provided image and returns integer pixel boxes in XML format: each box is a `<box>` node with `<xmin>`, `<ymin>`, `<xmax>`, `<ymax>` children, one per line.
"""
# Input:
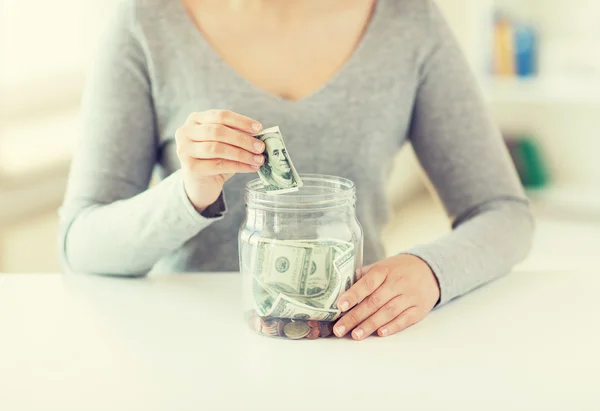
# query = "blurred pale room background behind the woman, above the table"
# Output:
<box><xmin>0</xmin><ymin>0</ymin><xmax>600</xmax><ymax>272</ymax></box>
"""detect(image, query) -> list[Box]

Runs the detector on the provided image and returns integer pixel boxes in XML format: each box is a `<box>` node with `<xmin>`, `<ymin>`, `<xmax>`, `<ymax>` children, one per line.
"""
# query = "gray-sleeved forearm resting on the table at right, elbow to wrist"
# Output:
<box><xmin>406</xmin><ymin>199</ymin><xmax>534</xmax><ymax>306</ymax></box>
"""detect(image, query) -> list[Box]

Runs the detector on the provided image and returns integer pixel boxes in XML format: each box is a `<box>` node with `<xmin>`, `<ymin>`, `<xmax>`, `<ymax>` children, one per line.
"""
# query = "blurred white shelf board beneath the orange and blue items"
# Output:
<box><xmin>481</xmin><ymin>77</ymin><xmax>600</xmax><ymax>104</ymax></box>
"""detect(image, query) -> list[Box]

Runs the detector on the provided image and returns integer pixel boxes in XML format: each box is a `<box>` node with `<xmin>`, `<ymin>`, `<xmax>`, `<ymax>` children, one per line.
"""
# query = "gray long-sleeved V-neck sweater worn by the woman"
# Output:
<box><xmin>59</xmin><ymin>0</ymin><xmax>533</xmax><ymax>304</ymax></box>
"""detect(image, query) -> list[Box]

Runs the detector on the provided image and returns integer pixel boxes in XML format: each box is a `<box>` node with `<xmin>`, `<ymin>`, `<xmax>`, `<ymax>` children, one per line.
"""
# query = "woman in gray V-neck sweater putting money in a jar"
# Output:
<box><xmin>60</xmin><ymin>0</ymin><xmax>533</xmax><ymax>340</ymax></box>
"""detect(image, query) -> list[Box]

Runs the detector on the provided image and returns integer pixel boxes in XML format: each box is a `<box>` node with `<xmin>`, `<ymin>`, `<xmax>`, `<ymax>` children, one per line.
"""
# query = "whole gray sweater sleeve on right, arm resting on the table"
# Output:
<box><xmin>407</xmin><ymin>0</ymin><xmax>534</xmax><ymax>305</ymax></box>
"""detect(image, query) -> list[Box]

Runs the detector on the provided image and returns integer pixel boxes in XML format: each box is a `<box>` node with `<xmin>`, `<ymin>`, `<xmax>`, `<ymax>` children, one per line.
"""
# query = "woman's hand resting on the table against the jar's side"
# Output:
<box><xmin>334</xmin><ymin>254</ymin><xmax>440</xmax><ymax>340</ymax></box>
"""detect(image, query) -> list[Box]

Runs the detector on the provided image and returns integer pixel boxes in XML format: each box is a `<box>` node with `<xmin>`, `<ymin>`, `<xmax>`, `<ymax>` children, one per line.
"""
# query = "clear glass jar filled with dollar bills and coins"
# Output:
<box><xmin>238</xmin><ymin>174</ymin><xmax>363</xmax><ymax>339</ymax></box>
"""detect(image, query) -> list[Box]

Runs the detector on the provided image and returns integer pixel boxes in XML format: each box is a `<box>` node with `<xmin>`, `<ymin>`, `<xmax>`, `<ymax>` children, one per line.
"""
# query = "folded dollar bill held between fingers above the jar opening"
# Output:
<box><xmin>254</xmin><ymin>126</ymin><xmax>303</xmax><ymax>194</ymax></box>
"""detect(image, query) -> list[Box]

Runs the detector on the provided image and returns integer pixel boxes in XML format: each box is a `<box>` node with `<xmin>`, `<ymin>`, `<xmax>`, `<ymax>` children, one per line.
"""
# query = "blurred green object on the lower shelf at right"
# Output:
<box><xmin>506</xmin><ymin>135</ymin><xmax>550</xmax><ymax>188</ymax></box>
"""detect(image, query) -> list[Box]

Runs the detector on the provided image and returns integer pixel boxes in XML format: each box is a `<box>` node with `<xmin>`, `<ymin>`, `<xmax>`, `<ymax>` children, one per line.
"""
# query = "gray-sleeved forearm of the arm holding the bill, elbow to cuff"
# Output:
<box><xmin>59</xmin><ymin>172</ymin><xmax>224</xmax><ymax>275</ymax></box>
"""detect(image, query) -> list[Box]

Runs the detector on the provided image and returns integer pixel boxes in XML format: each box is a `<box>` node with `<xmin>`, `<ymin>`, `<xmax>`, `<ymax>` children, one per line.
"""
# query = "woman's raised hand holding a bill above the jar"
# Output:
<box><xmin>175</xmin><ymin>110</ymin><xmax>265</xmax><ymax>212</ymax></box>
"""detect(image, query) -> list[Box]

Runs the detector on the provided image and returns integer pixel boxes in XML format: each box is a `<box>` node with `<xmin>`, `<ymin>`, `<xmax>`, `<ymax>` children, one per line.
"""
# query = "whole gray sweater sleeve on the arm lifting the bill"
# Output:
<box><xmin>59</xmin><ymin>1</ymin><xmax>225</xmax><ymax>276</ymax></box>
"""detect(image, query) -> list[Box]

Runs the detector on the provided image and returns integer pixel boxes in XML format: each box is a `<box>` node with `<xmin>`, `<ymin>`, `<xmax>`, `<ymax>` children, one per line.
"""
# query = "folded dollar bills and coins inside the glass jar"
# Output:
<box><xmin>242</xmin><ymin>234</ymin><xmax>355</xmax><ymax>339</ymax></box>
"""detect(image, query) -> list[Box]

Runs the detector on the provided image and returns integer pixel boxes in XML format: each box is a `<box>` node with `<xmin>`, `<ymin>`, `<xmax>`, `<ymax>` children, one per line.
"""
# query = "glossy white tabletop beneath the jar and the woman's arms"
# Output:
<box><xmin>0</xmin><ymin>269</ymin><xmax>600</xmax><ymax>411</ymax></box>
